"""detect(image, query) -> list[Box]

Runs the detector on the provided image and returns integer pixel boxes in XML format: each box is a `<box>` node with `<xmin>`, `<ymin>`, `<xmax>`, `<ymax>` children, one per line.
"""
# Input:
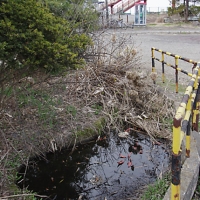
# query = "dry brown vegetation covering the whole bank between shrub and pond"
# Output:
<box><xmin>0</xmin><ymin>30</ymin><xmax>174</xmax><ymax>196</ymax></box>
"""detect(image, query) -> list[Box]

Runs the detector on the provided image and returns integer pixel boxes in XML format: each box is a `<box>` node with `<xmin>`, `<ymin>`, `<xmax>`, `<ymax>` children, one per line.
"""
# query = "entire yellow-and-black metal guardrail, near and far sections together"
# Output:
<box><xmin>151</xmin><ymin>48</ymin><xmax>200</xmax><ymax>200</ymax></box>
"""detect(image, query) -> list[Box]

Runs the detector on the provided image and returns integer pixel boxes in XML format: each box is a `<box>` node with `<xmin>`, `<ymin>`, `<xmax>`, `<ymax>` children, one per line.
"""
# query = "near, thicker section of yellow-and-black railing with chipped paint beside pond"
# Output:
<box><xmin>171</xmin><ymin>63</ymin><xmax>200</xmax><ymax>200</ymax></box>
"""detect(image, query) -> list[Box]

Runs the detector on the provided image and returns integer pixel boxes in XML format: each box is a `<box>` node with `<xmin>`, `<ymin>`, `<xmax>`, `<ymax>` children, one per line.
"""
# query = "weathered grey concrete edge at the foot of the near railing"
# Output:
<box><xmin>163</xmin><ymin>131</ymin><xmax>200</xmax><ymax>200</ymax></box>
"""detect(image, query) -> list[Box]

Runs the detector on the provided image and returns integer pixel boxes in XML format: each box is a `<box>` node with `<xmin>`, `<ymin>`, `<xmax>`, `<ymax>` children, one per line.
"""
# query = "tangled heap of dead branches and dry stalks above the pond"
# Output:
<box><xmin>66</xmin><ymin>33</ymin><xmax>174</xmax><ymax>138</ymax></box>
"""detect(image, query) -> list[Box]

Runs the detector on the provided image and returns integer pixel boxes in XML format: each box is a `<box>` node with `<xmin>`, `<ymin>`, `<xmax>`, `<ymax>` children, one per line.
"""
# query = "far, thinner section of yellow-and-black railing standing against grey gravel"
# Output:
<box><xmin>151</xmin><ymin>47</ymin><xmax>197</xmax><ymax>93</ymax></box>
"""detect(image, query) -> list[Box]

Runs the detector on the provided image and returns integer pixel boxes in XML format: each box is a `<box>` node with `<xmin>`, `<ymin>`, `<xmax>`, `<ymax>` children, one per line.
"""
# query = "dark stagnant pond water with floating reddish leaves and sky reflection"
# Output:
<box><xmin>17</xmin><ymin>133</ymin><xmax>169</xmax><ymax>200</ymax></box>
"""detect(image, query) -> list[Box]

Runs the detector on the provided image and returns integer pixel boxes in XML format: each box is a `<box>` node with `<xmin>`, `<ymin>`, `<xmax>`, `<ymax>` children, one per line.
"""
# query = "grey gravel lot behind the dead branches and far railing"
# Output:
<box><xmin>109</xmin><ymin>24</ymin><xmax>200</xmax><ymax>82</ymax></box>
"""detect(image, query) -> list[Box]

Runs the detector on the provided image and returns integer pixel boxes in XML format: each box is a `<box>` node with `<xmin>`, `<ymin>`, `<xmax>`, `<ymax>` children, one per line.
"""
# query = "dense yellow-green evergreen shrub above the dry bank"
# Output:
<box><xmin>0</xmin><ymin>0</ymin><xmax>91</xmax><ymax>73</ymax></box>
